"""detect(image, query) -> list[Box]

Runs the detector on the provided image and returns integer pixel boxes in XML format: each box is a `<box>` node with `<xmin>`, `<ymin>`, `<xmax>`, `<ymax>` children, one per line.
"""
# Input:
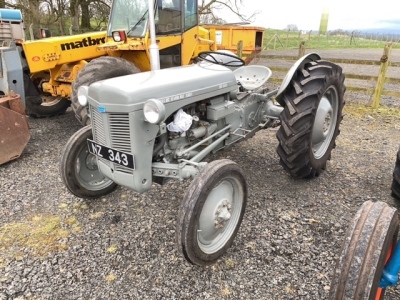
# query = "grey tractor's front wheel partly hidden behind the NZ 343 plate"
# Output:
<box><xmin>60</xmin><ymin>125</ymin><xmax>117</xmax><ymax>198</ymax></box>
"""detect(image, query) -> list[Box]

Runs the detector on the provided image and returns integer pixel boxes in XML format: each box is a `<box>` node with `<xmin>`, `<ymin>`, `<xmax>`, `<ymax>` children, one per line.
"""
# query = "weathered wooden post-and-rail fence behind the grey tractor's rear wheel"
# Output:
<box><xmin>248</xmin><ymin>42</ymin><xmax>400</xmax><ymax>108</ymax></box>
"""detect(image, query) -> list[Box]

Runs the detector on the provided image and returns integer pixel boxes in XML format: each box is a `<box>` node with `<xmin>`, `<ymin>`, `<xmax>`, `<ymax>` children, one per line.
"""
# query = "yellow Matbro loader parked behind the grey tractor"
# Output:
<box><xmin>0</xmin><ymin>0</ymin><xmax>265</xmax><ymax>164</ymax></box>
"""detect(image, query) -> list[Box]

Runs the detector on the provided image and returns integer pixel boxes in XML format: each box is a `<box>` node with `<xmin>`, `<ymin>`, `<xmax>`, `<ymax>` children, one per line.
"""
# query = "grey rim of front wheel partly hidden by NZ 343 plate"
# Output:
<box><xmin>75</xmin><ymin>144</ymin><xmax>113</xmax><ymax>191</ymax></box>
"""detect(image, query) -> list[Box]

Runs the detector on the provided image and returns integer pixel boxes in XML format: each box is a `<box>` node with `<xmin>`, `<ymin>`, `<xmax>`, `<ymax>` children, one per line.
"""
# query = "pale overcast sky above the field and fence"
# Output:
<box><xmin>224</xmin><ymin>0</ymin><xmax>400</xmax><ymax>30</ymax></box>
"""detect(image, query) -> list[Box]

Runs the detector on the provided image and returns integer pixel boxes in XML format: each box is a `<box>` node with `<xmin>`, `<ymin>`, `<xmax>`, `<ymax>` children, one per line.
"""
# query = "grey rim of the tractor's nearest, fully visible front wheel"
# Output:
<box><xmin>197</xmin><ymin>178</ymin><xmax>244</xmax><ymax>254</ymax></box>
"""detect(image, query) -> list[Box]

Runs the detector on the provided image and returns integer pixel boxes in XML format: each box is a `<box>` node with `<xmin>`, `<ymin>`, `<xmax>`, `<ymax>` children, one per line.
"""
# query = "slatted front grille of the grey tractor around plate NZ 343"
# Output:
<box><xmin>90</xmin><ymin>106</ymin><xmax>133</xmax><ymax>174</ymax></box>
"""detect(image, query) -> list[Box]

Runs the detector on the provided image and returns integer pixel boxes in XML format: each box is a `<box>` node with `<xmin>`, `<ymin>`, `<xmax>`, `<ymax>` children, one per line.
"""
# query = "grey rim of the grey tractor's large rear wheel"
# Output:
<box><xmin>311</xmin><ymin>86</ymin><xmax>339</xmax><ymax>159</ymax></box>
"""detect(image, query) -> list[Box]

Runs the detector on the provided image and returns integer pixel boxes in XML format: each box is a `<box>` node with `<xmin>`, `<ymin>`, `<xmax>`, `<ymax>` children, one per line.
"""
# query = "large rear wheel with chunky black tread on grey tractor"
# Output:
<box><xmin>276</xmin><ymin>60</ymin><xmax>346</xmax><ymax>178</ymax></box>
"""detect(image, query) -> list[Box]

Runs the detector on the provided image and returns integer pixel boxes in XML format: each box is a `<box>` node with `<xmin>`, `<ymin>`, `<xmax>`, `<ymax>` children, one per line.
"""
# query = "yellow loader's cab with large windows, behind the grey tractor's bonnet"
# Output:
<box><xmin>99</xmin><ymin>0</ymin><xmax>203</xmax><ymax>71</ymax></box>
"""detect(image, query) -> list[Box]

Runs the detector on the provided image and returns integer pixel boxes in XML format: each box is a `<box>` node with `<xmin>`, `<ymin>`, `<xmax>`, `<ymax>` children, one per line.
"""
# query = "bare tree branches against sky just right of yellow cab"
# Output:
<box><xmin>199</xmin><ymin>0</ymin><xmax>259</xmax><ymax>24</ymax></box>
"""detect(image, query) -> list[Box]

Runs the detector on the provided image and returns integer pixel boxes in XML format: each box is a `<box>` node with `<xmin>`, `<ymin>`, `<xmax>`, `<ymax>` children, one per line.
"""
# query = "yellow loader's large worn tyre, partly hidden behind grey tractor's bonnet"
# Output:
<box><xmin>71</xmin><ymin>56</ymin><xmax>140</xmax><ymax>126</ymax></box>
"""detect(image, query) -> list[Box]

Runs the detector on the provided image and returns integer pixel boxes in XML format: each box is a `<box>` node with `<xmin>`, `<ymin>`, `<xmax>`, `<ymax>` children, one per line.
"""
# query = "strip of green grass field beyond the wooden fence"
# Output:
<box><xmin>264</xmin><ymin>29</ymin><xmax>400</xmax><ymax>50</ymax></box>
